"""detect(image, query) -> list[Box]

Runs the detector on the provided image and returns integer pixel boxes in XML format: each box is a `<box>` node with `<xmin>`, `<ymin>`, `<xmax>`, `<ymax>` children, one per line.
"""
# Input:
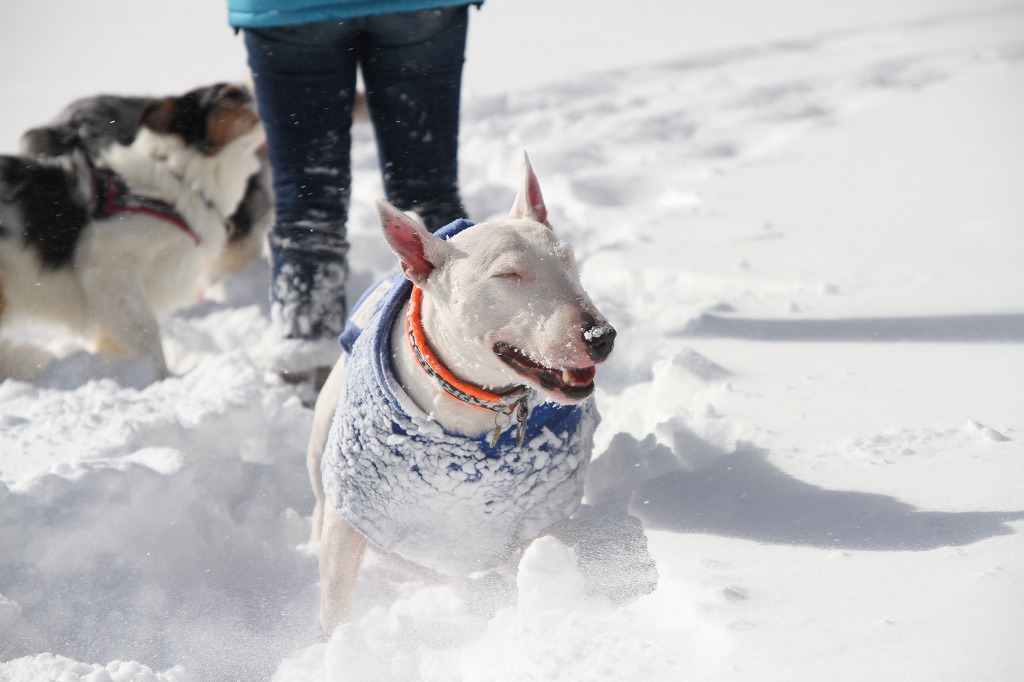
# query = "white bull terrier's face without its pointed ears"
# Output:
<box><xmin>423</xmin><ymin>219</ymin><xmax>610</xmax><ymax>402</ymax></box>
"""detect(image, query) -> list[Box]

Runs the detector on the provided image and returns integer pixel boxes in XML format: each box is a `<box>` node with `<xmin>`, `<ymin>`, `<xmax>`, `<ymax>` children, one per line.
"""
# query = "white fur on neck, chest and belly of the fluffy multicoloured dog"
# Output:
<box><xmin>0</xmin><ymin>116</ymin><xmax>263</xmax><ymax>377</ymax></box>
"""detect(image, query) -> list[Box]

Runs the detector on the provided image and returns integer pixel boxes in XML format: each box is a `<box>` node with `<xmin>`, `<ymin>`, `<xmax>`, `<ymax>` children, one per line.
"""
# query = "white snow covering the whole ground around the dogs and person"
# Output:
<box><xmin>0</xmin><ymin>0</ymin><xmax>1024</xmax><ymax>682</ymax></box>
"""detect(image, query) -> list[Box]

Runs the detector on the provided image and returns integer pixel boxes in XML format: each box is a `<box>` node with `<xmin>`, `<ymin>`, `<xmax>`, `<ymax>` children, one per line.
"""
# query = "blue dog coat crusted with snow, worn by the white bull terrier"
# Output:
<box><xmin>322</xmin><ymin>220</ymin><xmax>598</xmax><ymax>574</ymax></box>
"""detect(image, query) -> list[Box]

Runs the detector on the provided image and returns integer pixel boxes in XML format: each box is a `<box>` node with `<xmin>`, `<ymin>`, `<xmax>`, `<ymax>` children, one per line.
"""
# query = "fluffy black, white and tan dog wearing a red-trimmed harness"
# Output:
<box><xmin>0</xmin><ymin>84</ymin><xmax>264</xmax><ymax>376</ymax></box>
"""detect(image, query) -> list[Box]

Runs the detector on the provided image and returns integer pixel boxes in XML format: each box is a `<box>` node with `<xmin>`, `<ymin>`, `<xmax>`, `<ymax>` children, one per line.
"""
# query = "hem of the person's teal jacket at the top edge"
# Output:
<box><xmin>227</xmin><ymin>0</ymin><xmax>483</xmax><ymax>29</ymax></box>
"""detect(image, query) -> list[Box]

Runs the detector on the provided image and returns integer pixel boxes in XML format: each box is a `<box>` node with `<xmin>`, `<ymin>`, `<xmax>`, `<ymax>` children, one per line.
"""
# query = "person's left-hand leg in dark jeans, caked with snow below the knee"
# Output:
<box><xmin>245</xmin><ymin>22</ymin><xmax>356</xmax><ymax>350</ymax></box>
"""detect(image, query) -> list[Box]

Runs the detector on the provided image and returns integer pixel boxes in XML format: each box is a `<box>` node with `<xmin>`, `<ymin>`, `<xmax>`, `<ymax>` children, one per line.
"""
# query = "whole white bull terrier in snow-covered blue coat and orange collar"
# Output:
<box><xmin>299</xmin><ymin>157</ymin><xmax>615</xmax><ymax>635</ymax></box>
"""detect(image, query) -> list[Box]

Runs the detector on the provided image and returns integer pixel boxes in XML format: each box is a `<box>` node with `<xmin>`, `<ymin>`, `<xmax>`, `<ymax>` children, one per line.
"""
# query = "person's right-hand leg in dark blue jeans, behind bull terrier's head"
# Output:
<box><xmin>359</xmin><ymin>7</ymin><xmax>468</xmax><ymax>229</ymax></box>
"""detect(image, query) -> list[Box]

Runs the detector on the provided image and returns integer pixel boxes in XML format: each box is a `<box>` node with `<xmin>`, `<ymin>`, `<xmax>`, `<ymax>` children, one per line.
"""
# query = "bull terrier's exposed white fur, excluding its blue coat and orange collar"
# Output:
<box><xmin>307</xmin><ymin>153</ymin><xmax>603</xmax><ymax>634</ymax></box>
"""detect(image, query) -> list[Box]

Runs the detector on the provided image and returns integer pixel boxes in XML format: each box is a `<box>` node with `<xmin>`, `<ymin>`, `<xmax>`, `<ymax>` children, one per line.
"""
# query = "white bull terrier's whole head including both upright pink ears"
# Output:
<box><xmin>377</xmin><ymin>155</ymin><xmax>615</xmax><ymax>402</ymax></box>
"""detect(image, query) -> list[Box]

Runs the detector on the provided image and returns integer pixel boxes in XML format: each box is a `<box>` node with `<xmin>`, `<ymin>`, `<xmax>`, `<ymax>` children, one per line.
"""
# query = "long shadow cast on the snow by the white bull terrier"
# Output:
<box><xmin>588</xmin><ymin>434</ymin><xmax>1024</xmax><ymax>551</ymax></box>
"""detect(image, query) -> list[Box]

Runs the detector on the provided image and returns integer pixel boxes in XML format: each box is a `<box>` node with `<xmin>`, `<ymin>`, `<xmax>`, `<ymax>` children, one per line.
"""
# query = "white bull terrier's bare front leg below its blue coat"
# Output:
<box><xmin>321</xmin><ymin>505</ymin><xmax>367</xmax><ymax>640</ymax></box>
